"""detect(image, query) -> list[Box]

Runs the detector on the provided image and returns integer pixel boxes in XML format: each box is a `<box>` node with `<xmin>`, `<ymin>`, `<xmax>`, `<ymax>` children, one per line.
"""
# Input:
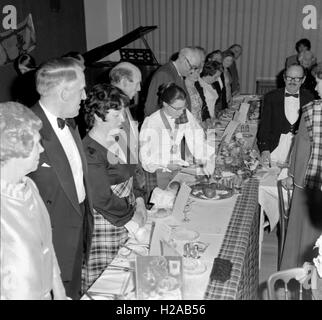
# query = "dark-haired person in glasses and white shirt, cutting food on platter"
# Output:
<box><xmin>140</xmin><ymin>83</ymin><xmax>215</xmax><ymax>189</ymax></box>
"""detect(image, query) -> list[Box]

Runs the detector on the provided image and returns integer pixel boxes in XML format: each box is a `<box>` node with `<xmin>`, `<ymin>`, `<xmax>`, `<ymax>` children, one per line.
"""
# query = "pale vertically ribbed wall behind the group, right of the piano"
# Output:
<box><xmin>123</xmin><ymin>0</ymin><xmax>322</xmax><ymax>92</ymax></box>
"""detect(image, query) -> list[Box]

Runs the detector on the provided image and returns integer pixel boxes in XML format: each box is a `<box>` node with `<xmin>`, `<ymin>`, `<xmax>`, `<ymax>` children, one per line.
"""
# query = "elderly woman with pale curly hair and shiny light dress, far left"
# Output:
<box><xmin>0</xmin><ymin>102</ymin><xmax>66</xmax><ymax>300</ymax></box>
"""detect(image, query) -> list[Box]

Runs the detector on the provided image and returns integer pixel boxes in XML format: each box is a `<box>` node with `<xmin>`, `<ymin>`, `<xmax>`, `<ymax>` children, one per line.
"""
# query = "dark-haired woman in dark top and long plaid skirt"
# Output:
<box><xmin>82</xmin><ymin>84</ymin><xmax>146</xmax><ymax>290</ymax></box>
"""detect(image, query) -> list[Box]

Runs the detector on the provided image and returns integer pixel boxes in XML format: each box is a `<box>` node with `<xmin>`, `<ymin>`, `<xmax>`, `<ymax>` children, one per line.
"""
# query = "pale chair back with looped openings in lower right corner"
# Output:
<box><xmin>267</xmin><ymin>268</ymin><xmax>312</xmax><ymax>300</ymax></box>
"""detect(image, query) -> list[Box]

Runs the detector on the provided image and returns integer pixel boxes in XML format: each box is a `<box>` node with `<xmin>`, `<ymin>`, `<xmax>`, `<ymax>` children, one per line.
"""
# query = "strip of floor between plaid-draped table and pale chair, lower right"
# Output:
<box><xmin>258</xmin><ymin>229</ymin><xmax>277</xmax><ymax>300</ymax></box>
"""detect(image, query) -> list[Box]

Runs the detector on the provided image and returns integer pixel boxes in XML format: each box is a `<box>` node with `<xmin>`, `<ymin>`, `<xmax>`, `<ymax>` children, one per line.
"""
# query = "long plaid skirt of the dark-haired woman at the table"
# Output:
<box><xmin>82</xmin><ymin>210</ymin><xmax>128</xmax><ymax>292</ymax></box>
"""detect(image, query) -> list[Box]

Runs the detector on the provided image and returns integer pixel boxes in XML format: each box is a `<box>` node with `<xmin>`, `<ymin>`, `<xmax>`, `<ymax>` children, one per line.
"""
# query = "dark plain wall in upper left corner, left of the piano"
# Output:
<box><xmin>0</xmin><ymin>0</ymin><xmax>86</xmax><ymax>101</ymax></box>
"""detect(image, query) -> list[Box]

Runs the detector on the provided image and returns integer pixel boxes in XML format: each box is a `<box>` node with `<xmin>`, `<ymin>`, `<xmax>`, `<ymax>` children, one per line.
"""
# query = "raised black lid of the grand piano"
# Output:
<box><xmin>83</xmin><ymin>26</ymin><xmax>157</xmax><ymax>65</ymax></box>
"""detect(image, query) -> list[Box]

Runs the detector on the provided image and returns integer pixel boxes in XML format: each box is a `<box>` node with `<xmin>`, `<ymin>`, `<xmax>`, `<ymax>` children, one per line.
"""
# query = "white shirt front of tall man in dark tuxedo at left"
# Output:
<box><xmin>39</xmin><ymin>103</ymin><xmax>86</xmax><ymax>203</ymax></box>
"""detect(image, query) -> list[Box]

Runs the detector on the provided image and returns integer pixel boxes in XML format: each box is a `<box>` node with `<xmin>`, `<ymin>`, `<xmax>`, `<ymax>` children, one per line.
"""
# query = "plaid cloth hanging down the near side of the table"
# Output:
<box><xmin>204</xmin><ymin>178</ymin><xmax>259</xmax><ymax>300</ymax></box>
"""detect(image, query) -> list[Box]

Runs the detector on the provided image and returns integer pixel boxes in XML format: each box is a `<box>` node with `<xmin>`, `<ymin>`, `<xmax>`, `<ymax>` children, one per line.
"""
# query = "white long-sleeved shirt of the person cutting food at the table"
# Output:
<box><xmin>139</xmin><ymin>110</ymin><xmax>215</xmax><ymax>172</ymax></box>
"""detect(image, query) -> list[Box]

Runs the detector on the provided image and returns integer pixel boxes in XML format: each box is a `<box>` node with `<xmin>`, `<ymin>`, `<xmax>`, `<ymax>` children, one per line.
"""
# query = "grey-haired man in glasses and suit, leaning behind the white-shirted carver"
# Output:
<box><xmin>144</xmin><ymin>47</ymin><xmax>202</xmax><ymax>117</ymax></box>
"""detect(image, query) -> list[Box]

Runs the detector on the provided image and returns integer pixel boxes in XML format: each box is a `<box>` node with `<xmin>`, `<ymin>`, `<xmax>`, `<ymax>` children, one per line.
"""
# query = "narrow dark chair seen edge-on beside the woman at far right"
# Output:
<box><xmin>277</xmin><ymin>180</ymin><xmax>291</xmax><ymax>270</ymax></box>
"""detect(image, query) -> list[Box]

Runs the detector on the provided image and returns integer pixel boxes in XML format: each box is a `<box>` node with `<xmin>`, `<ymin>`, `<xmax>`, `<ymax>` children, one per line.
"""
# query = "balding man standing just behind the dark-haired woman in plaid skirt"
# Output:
<box><xmin>109</xmin><ymin>62</ymin><xmax>146</xmax><ymax>201</ymax></box>
